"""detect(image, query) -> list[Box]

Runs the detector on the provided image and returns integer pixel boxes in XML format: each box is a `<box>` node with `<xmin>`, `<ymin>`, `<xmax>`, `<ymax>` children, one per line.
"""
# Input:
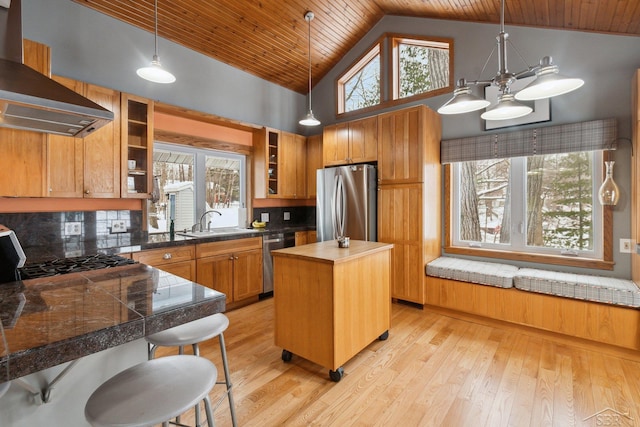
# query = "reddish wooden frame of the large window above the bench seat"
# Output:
<box><xmin>443</xmin><ymin>151</ymin><xmax>614</xmax><ymax>270</ymax></box>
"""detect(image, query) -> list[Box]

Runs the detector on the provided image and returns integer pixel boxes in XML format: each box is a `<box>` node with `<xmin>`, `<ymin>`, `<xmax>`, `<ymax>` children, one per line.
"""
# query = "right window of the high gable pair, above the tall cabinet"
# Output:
<box><xmin>392</xmin><ymin>37</ymin><xmax>451</xmax><ymax>99</ymax></box>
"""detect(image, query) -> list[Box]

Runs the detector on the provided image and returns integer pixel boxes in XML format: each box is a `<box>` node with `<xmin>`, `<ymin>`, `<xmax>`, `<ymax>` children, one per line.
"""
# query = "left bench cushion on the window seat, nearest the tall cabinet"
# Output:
<box><xmin>426</xmin><ymin>257</ymin><xmax>518</xmax><ymax>288</ymax></box>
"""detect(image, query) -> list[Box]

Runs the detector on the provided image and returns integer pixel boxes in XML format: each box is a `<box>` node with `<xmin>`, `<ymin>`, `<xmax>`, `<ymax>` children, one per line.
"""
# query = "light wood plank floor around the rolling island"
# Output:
<box><xmin>159</xmin><ymin>299</ymin><xmax>640</xmax><ymax>427</ymax></box>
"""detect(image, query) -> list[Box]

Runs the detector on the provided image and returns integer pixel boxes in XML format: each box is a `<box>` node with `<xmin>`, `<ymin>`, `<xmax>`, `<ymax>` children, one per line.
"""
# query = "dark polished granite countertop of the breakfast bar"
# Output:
<box><xmin>0</xmin><ymin>264</ymin><xmax>226</xmax><ymax>383</ymax></box>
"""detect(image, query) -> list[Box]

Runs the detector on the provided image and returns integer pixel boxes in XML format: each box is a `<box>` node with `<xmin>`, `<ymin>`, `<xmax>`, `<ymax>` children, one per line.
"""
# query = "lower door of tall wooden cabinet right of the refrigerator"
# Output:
<box><xmin>378</xmin><ymin>183</ymin><xmax>424</xmax><ymax>304</ymax></box>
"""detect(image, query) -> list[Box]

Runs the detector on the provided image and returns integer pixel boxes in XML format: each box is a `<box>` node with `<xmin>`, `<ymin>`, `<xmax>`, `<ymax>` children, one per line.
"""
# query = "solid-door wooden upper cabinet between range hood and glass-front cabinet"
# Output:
<box><xmin>47</xmin><ymin>76</ymin><xmax>121</xmax><ymax>198</ymax></box>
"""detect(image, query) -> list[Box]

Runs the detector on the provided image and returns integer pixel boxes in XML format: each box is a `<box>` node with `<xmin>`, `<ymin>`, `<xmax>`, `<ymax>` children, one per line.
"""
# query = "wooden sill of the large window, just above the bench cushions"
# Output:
<box><xmin>444</xmin><ymin>246</ymin><xmax>615</xmax><ymax>270</ymax></box>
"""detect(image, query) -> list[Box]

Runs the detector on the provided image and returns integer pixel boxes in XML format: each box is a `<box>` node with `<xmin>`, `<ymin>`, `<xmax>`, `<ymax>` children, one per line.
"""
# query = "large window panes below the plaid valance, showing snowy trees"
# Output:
<box><xmin>452</xmin><ymin>151</ymin><xmax>603</xmax><ymax>259</ymax></box>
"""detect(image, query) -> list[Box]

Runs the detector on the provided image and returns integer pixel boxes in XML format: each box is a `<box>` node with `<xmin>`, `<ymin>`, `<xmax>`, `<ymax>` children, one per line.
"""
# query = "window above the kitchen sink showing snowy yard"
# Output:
<box><xmin>148</xmin><ymin>143</ymin><xmax>246</xmax><ymax>233</ymax></box>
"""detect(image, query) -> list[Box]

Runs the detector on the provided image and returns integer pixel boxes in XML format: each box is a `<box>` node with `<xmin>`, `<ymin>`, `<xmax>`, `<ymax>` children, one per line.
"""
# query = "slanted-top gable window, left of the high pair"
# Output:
<box><xmin>338</xmin><ymin>43</ymin><xmax>380</xmax><ymax>113</ymax></box>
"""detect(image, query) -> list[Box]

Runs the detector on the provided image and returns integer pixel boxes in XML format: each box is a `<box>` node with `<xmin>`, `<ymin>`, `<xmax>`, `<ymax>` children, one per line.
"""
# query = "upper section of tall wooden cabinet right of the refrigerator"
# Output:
<box><xmin>378</xmin><ymin>106</ymin><xmax>441</xmax><ymax>184</ymax></box>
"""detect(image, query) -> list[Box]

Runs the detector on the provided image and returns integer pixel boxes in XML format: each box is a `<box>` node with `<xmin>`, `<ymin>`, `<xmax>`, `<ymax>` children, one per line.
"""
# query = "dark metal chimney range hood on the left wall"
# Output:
<box><xmin>0</xmin><ymin>0</ymin><xmax>113</xmax><ymax>138</ymax></box>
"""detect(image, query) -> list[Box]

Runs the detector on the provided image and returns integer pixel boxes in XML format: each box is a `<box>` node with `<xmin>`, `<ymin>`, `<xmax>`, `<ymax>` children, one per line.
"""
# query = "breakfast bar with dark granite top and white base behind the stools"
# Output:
<box><xmin>0</xmin><ymin>264</ymin><xmax>226</xmax><ymax>427</ymax></box>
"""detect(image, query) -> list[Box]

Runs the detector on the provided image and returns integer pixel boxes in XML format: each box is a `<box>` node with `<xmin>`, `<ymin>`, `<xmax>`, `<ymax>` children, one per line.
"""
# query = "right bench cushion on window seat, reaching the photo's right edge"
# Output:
<box><xmin>514</xmin><ymin>268</ymin><xmax>640</xmax><ymax>307</ymax></box>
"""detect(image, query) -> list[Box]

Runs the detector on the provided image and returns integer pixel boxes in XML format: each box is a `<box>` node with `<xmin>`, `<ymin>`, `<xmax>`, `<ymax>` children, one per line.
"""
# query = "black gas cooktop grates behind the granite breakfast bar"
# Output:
<box><xmin>20</xmin><ymin>254</ymin><xmax>136</xmax><ymax>280</ymax></box>
